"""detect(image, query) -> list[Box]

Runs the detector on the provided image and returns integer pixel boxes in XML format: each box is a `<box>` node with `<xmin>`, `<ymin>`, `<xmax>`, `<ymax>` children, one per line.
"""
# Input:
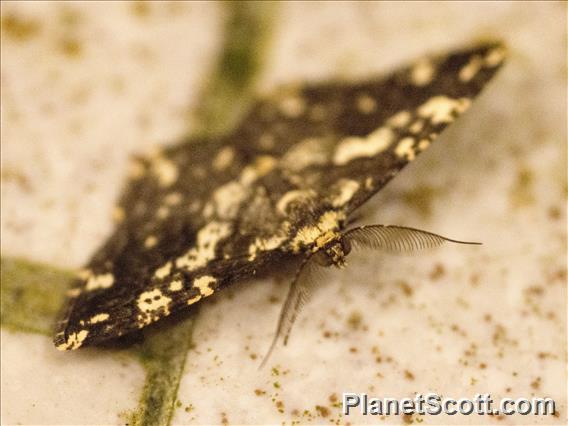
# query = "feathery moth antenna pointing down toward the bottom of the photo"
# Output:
<box><xmin>259</xmin><ymin>256</ymin><xmax>320</xmax><ymax>368</ymax></box>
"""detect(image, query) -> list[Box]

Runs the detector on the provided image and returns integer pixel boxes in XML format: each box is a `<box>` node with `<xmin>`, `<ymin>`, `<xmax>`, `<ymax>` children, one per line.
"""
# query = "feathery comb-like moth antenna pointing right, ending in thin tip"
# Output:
<box><xmin>343</xmin><ymin>225</ymin><xmax>481</xmax><ymax>253</ymax></box>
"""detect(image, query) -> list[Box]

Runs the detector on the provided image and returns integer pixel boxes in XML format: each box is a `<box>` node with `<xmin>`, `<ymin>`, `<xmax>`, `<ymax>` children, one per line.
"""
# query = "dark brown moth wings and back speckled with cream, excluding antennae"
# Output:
<box><xmin>55</xmin><ymin>43</ymin><xmax>505</xmax><ymax>350</ymax></box>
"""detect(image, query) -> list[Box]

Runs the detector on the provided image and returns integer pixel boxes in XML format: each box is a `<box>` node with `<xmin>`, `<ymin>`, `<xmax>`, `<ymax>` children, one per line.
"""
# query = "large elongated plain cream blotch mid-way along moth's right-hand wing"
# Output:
<box><xmin>333</xmin><ymin>127</ymin><xmax>394</xmax><ymax>166</ymax></box>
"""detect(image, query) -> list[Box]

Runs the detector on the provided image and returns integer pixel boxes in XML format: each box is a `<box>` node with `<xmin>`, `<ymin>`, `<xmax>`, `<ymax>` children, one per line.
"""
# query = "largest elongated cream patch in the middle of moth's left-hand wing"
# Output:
<box><xmin>176</xmin><ymin>221</ymin><xmax>232</xmax><ymax>271</ymax></box>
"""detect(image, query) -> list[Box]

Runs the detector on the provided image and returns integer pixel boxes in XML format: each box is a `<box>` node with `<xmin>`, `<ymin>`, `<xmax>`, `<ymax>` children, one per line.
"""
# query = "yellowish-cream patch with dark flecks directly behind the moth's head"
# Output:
<box><xmin>290</xmin><ymin>210</ymin><xmax>345</xmax><ymax>253</ymax></box>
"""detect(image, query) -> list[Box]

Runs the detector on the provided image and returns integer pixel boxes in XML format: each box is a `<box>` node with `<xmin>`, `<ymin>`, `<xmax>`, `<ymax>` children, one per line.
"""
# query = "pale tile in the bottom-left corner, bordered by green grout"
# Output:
<box><xmin>1</xmin><ymin>330</ymin><xmax>144</xmax><ymax>425</ymax></box>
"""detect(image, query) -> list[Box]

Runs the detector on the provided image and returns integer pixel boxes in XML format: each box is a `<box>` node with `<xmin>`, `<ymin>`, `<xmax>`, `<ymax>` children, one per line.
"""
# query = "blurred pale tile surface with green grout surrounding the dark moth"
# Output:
<box><xmin>1</xmin><ymin>1</ymin><xmax>568</xmax><ymax>424</ymax></box>
